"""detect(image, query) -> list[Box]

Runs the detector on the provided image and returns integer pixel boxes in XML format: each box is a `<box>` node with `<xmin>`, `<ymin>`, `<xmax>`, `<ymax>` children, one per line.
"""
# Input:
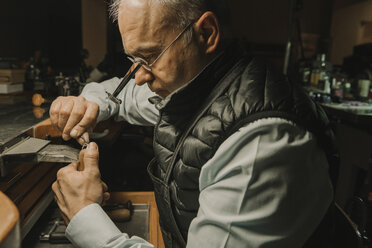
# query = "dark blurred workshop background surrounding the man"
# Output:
<box><xmin>0</xmin><ymin>0</ymin><xmax>372</xmax><ymax>247</ymax></box>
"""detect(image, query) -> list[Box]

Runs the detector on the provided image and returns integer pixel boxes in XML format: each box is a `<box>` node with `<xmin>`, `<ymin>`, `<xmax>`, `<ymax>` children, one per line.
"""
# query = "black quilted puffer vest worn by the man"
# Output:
<box><xmin>148</xmin><ymin>43</ymin><xmax>331</xmax><ymax>248</ymax></box>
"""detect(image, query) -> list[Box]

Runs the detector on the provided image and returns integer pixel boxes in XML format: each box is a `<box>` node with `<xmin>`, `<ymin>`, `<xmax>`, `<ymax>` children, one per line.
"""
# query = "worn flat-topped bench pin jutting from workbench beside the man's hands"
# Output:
<box><xmin>0</xmin><ymin>136</ymin><xmax>80</xmax><ymax>177</ymax></box>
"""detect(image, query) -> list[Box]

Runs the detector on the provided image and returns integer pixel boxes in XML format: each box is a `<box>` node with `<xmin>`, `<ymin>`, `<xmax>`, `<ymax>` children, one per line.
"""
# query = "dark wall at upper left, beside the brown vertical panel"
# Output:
<box><xmin>0</xmin><ymin>0</ymin><xmax>81</xmax><ymax>71</ymax></box>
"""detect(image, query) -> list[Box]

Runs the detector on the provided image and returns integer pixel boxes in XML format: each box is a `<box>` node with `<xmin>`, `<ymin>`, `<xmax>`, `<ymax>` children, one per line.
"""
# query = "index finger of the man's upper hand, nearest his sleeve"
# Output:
<box><xmin>70</xmin><ymin>103</ymin><xmax>99</xmax><ymax>138</ymax></box>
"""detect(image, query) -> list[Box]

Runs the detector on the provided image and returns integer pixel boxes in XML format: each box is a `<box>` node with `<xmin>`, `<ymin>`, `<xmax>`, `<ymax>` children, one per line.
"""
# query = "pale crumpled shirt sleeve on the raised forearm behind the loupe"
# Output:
<box><xmin>80</xmin><ymin>78</ymin><xmax>159</xmax><ymax>126</ymax></box>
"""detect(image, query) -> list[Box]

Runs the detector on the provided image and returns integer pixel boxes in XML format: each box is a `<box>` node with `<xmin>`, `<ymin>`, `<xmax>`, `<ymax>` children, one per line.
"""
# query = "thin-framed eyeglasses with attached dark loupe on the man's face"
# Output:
<box><xmin>106</xmin><ymin>22</ymin><xmax>193</xmax><ymax>105</ymax></box>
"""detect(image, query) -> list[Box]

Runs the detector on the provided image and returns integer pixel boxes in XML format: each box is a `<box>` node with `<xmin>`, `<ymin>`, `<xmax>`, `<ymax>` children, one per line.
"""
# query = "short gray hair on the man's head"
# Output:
<box><xmin>109</xmin><ymin>0</ymin><xmax>231</xmax><ymax>40</ymax></box>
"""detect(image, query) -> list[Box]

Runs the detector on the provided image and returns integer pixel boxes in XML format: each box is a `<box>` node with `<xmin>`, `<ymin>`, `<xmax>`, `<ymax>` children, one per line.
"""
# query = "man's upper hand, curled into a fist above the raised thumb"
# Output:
<box><xmin>49</xmin><ymin>96</ymin><xmax>99</xmax><ymax>140</ymax></box>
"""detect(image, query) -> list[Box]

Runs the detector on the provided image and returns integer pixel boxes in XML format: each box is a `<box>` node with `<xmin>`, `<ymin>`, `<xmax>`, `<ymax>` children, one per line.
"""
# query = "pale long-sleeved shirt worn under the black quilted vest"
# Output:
<box><xmin>66</xmin><ymin>79</ymin><xmax>333</xmax><ymax>248</ymax></box>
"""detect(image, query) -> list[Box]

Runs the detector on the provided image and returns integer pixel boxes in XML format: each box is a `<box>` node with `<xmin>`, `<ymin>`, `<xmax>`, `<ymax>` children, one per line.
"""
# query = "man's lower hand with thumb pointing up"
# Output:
<box><xmin>52</xmin><ymin>142</ymin><xmax>110</xmax><ymax>221</ymax></box>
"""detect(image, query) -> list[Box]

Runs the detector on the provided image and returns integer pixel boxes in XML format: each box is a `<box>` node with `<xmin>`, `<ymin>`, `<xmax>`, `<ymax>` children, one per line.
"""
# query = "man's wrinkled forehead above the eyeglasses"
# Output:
<box><xmin>118</xmin><ymin>0</ymin><xmax>171</xmax><ymax>51</ymax></box>
